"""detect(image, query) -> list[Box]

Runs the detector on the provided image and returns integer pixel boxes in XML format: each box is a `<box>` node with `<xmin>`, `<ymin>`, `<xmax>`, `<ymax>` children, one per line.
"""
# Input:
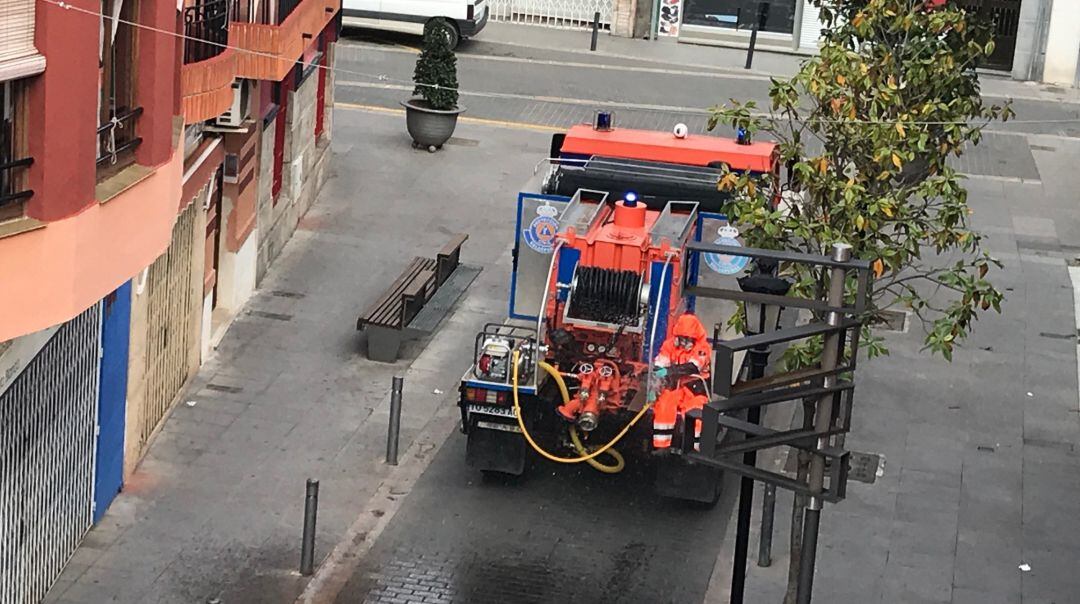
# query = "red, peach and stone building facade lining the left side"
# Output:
<box><xmin>0</xmin><ymin>0</ymin><xmax>339</xmax><ymax>602</ymax></box>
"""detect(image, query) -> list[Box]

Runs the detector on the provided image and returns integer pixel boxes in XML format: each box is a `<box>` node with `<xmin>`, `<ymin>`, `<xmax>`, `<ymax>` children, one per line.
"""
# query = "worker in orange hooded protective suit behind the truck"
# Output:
<box><xmin>650</xmin><ymin>312</ymin><xmax>713</xmax><ymax>449</ymax></box>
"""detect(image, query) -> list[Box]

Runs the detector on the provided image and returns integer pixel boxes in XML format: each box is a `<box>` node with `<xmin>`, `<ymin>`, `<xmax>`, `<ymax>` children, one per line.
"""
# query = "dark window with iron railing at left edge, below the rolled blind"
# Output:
<box><xmin>0</xmin><ymin>81</ymin><xmax>33</xmax><ymax>220</ymax></box>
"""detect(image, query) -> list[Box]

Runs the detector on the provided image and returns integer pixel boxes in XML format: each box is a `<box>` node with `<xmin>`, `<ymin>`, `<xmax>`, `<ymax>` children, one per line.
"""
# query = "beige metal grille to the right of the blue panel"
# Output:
<box><xmin>139</xmin><ymin>203</ymin><xmax>199</xmax><ymax>451</ymax></box>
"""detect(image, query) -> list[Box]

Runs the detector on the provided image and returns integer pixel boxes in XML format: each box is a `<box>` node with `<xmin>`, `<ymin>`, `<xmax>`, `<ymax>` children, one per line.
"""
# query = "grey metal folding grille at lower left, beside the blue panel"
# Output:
<box><xmin>0</xmin><ymin>305</ymin><xmax>100</xmax><ymax>604</ymax></box>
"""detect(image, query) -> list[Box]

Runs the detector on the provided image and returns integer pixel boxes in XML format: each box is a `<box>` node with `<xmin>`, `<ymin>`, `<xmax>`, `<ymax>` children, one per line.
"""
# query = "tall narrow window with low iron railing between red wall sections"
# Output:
<box><xmin>97</xmin><ymin>0</ymin><xmax>143</xmax><ymax>172</ymax></box>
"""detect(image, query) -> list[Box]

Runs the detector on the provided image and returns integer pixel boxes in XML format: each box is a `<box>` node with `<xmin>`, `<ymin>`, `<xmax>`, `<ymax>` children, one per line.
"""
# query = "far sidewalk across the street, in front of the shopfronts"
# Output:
<box><xmin>475</xmin><ymin>23</ymin><xmax>1080</xmax><ymax>104</ymax></box>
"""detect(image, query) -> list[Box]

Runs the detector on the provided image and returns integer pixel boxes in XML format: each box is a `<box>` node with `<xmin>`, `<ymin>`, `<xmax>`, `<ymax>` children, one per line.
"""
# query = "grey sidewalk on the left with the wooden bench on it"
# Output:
<box><xmin>48</xmin><ymin>110</ymin><xmax>548</xmax><ymax>604</ymax></box>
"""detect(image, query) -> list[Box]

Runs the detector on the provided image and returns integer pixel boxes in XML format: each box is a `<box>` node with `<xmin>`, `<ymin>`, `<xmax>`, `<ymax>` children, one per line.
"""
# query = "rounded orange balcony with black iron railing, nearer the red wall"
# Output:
<box><xmin>180</xmin><ymin>0</ymin><xmax>237</xmax><ymax>124</ymax></box>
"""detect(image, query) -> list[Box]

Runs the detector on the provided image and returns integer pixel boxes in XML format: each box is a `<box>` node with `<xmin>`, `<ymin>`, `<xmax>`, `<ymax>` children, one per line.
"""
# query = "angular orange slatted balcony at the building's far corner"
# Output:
<box><xmin>230</xmin><ymin>0</ymin><xmax>340</xmax><ymax>82</ymax></box>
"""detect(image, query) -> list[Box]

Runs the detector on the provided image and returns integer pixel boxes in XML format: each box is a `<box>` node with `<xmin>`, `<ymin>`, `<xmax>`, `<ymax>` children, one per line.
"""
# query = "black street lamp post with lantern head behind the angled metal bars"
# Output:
<box><xmin>731</xmin><ymin>259</ymin><xmax>792</xmax><ymax>604</ymax></box>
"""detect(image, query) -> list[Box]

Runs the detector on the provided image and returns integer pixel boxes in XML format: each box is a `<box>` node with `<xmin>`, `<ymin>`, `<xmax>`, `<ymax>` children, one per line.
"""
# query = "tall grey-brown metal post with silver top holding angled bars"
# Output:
<box><xmin>796</xmin><ymin>243</ymin><xmax>851</xmax><ymax>604</ymax></box>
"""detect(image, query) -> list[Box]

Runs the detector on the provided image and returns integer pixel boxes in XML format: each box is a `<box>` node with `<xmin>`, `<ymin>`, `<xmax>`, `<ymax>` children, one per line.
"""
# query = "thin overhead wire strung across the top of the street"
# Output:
<box><xmin>40</xmin><ymin>0</ymin><xmax>1080</xmax><ymax>126</ymax></box>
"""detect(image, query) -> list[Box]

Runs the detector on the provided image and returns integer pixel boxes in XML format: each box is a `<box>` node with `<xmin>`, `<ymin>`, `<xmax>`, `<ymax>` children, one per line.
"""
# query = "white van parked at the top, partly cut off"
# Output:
<box><xmin>341</xmin><ymin>0</ymin><xmax>487</xmax><ymax>49</ymax></box>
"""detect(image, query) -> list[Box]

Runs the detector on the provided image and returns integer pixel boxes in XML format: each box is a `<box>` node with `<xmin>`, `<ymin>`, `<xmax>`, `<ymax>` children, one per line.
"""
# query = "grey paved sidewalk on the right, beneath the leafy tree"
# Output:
<box><xmin>706</xmin><ymin>136</ymin><xmax>1080</xmax><ymax>604</ymax></box>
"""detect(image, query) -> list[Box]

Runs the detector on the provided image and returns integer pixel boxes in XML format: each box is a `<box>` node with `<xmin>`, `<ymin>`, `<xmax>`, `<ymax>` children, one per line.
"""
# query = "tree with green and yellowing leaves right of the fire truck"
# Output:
<box><xmin>710</xmin><ymin>0</ymin><xmax>1012</xmax><ymax>599</ymax></box>
